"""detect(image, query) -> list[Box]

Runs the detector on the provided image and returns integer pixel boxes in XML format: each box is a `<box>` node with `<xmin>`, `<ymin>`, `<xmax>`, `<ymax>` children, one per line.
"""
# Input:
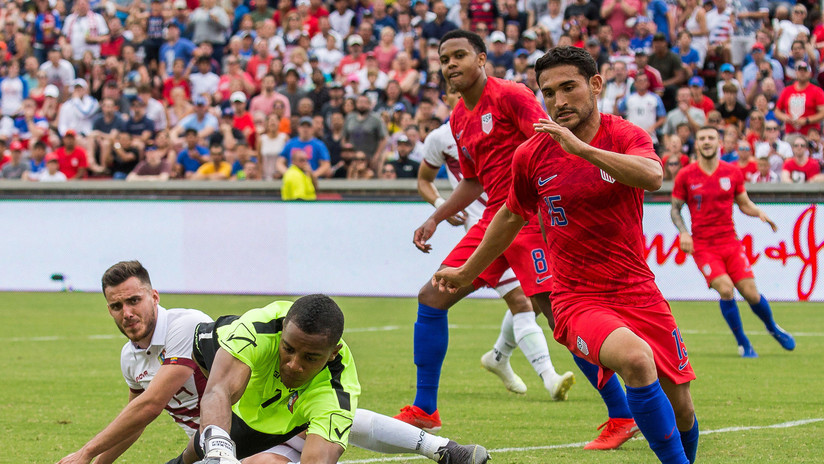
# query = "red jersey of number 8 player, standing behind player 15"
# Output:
<box><xmin>449</xmin><ymin>77</ymin><xmax>547</xmax><ymax>221</ymax></box>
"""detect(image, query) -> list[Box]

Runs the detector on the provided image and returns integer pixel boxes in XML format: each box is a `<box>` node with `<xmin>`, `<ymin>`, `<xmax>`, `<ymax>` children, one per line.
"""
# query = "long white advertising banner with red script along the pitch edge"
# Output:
<box><xmin>0</xmin><ymin>200</ymin><xmax>824</xmax><ymax>301</ymax></box>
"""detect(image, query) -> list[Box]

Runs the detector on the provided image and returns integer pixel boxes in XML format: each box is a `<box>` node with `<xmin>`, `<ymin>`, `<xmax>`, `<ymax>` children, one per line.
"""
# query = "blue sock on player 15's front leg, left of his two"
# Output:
<box><xmin>627</xmin><ymin>380</ymin><xmax>689</xmax><ymax>464</ymax></box>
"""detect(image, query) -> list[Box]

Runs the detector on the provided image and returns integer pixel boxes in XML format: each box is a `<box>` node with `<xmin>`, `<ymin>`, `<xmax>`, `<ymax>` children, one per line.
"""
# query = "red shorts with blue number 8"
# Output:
<box><xmin>442</xmin><ymin>221</ymin><xmax>552</xmax><ymax>296</ymax></box>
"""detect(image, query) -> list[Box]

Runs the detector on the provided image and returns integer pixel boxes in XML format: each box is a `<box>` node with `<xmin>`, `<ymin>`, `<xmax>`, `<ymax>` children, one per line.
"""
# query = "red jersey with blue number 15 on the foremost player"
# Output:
<box><xmin>506</xmin><ymin>114</ymin><xmax>664</xmax><ymax>308</ymax></box>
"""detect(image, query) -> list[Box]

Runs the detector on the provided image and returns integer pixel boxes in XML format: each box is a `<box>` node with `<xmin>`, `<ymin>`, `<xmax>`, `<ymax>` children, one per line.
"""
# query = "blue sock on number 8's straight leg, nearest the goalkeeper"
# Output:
<box><xmin>413</xmin><ymin>303</ymin><xmax>449</xmax><ymax>414</ymax></box>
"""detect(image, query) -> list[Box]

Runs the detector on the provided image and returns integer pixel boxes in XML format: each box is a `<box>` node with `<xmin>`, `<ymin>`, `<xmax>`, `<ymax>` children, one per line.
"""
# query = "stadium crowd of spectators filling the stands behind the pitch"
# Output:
<box><xmin>0</xmin><ymin>0</ymin><xmax>824</xmax><ymax>194</ymax></box>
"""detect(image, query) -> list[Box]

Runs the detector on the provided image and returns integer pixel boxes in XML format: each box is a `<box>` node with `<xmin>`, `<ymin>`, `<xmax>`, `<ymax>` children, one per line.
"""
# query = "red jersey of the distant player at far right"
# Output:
<box><xmin>672</xmin><ymin>161</ymin><xmax>744</xmax><ymax>247</ymax></box>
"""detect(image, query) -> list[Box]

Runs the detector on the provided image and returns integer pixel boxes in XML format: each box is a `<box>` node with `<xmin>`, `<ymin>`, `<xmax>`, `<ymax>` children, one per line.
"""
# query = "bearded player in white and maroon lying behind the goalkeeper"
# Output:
<box><xmin>60</xmin><ymin>261</ymin><xmax>487</xmax><ymax>464</ymax></box>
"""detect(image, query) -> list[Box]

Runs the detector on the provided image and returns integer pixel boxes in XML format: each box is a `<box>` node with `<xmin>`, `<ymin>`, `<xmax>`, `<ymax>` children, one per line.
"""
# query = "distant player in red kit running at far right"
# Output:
<box><xmin>670</xmin><ymin>127</ymin><xmax>795</xmax><ymax>358</ymax></box>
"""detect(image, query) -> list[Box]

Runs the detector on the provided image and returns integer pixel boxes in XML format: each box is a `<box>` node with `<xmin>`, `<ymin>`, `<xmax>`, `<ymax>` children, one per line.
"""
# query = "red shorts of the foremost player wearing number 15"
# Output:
<box><xmin>552</xmin><ymin>299</ymin><xmax>695</xmax><ymax>388</ymax></box>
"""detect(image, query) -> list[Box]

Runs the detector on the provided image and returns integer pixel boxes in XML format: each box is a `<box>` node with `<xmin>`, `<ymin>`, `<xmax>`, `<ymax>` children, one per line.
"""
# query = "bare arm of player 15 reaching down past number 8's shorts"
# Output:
<box><xmin>432</xmin><ymin>205</ymin><xmax>526</xmax><ymax>293</ymax></box>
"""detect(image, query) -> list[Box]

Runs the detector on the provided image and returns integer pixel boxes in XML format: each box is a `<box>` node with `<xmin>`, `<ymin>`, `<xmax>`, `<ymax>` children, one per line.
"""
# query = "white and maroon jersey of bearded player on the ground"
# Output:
<box><xmin>120</xmin><ymin>305</ymin><xmax>212</xmax><ymax>436</ymax></box>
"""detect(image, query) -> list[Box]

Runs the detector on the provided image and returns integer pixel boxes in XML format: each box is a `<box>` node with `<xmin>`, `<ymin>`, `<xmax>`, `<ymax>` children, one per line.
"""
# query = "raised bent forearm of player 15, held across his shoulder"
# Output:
<box><xmin>535</xmin><ymin>119</ymin><xmax>664</xmax><ymax>192</ymax></box>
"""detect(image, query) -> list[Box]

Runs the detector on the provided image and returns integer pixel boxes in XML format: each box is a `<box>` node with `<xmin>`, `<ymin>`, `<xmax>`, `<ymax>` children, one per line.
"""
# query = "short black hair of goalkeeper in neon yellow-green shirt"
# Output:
<box><xmin>283</xmin><ymin>293</ymin><xmax>343</xmax><ymax>344</ymax></box>
